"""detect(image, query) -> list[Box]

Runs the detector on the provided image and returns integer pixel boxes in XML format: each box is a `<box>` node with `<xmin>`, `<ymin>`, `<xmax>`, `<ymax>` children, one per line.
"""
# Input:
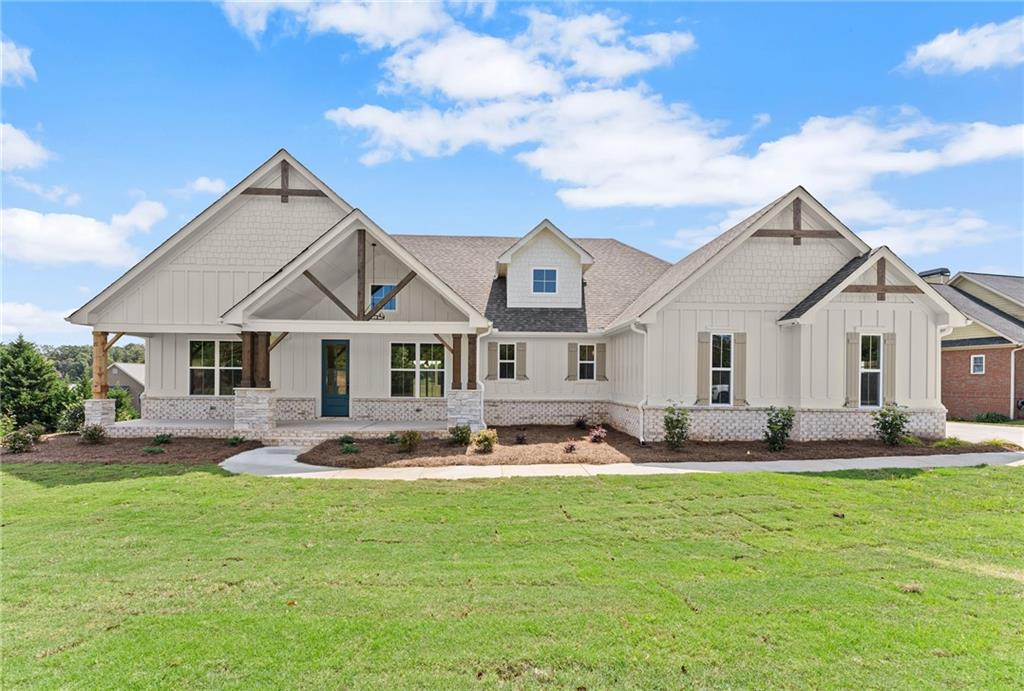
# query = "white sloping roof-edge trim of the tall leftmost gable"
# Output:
<box><xmin>65</xmin><ymin>148</ymin><xmax>352</xmax><ymax>325</ymax></box>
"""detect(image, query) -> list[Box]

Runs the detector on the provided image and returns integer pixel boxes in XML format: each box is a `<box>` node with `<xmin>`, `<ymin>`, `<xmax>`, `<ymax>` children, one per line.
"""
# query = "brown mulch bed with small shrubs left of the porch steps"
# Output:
<box><xmin>0</xmin><ymin>434</ymin><xmax>262</xmax><ymax>466</ymax></box>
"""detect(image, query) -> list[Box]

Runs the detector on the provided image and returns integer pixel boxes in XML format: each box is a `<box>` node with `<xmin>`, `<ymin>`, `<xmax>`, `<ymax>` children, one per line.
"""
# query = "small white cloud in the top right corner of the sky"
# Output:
<box><xmin>903</xmin><ymin>16</ymin><xmax>1024</xmax><ymax>75</ymax></box>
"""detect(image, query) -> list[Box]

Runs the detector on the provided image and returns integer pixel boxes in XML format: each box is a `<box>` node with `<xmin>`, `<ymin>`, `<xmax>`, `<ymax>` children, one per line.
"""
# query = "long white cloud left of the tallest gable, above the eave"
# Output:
<box><xmin>0</xmin><ymin>201</ymin><xmax>167</xmax><ymax>266</ymax></box>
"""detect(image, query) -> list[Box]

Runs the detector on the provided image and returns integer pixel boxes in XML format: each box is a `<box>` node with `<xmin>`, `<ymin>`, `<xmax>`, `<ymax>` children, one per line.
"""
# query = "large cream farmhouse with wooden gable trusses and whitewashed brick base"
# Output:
<box><xmin>68</xmin><ymin>149</ymin><xmax>967</xmax><ymax>439</ymax></box>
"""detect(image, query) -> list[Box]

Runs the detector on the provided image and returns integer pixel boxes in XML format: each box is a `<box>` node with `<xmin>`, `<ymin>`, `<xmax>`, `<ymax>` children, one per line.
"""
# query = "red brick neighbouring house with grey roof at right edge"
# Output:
<box><xmin>922</xmin><ymin>268</ymin><xmax>1024</xmax><ymax>420</ymax></box>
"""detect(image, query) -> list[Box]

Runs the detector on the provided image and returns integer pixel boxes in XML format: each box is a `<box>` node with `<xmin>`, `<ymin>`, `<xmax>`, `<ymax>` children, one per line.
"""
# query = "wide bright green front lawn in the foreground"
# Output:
<box><xmin>2</xmin><ymin>464</ymin><xmax>1024</xmax><ymax>689</ymax></box>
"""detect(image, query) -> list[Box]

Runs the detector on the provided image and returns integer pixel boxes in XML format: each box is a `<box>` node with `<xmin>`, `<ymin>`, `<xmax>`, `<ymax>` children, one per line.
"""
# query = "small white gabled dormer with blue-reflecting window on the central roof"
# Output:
<box><xmin>497</xmin><ymin>219</ymin><xmax>594</xmax><ymax>308</ymax></box>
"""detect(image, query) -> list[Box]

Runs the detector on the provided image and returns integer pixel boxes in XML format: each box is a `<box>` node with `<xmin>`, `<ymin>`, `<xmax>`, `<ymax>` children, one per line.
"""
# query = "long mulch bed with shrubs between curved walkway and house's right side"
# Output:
<box><xmin>298</xmin><ymin>425</ymin><xmax>1017</xmax><ymax>468</ymax></box>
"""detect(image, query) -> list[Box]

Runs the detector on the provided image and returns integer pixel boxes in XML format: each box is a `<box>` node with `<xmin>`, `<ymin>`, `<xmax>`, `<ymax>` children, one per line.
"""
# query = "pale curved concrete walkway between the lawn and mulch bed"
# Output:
<box><xmin>220</xmin><ymin>446</ymin><xmax>1024</xmax><ymax>480</ymax></box>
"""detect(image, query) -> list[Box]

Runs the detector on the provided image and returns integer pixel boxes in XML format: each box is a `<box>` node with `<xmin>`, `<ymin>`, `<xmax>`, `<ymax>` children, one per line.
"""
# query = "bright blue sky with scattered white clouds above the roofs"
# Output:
<box><xmin>0</xmin><ymin>2</ymin><xmax>1024</xmax><ymax>344</ymax></box>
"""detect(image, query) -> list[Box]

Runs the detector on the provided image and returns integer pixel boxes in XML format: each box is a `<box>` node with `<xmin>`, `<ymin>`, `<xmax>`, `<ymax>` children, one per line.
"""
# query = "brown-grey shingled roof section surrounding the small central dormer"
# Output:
<box><xmin>392</xmin><ymin>235</ymin><xmax>670</xmax><ymax>333</ymax></box>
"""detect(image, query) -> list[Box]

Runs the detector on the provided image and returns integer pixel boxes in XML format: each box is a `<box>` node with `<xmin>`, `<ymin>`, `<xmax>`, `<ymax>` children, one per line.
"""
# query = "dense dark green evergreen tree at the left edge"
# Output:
<box><xmin>0</xmin><ymin>335</ymin><xmax>69</xmax><ymax>430</ymax></box>
